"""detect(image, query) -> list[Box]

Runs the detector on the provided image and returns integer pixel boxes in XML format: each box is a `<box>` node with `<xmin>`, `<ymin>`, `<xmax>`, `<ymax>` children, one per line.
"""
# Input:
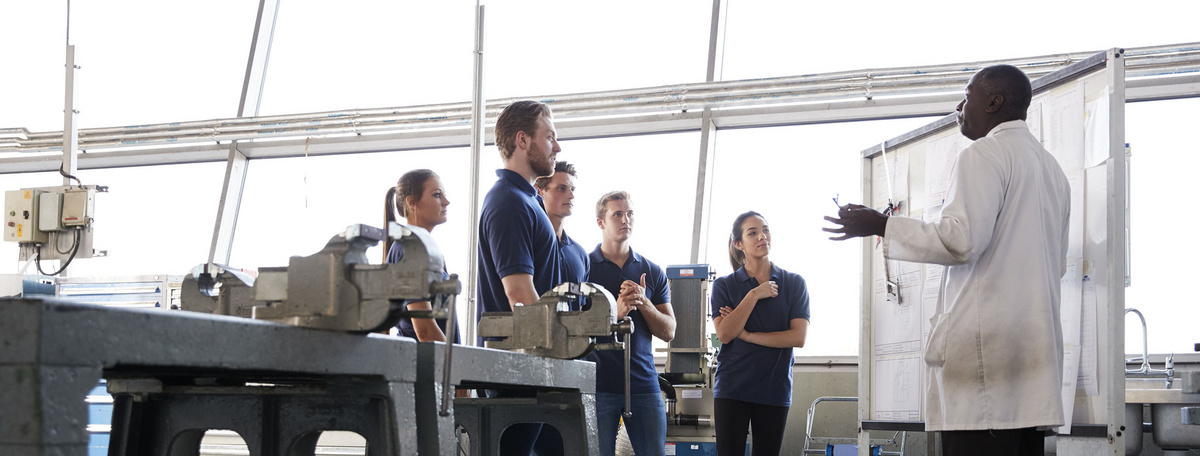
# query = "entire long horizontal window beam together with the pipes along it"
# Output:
<box><xmin>0</xmin><ymin>44</ymin><xmax>1200</xmax><ymax>174</ymax></box>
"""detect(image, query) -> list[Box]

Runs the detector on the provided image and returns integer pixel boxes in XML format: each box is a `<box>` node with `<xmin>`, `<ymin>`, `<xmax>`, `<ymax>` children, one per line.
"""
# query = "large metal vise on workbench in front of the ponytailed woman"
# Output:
<box><xmin>184</xmin><ymin>223</ymin><xmax>462</xmax><ymax>332</ymax></box>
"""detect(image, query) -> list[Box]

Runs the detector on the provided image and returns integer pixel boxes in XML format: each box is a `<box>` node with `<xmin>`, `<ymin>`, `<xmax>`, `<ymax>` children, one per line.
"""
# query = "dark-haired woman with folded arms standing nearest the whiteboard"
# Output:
<box><xmin>712</xmin><ymin>211</ymin><xmax>809</xmax><ymax>456</ymax></box>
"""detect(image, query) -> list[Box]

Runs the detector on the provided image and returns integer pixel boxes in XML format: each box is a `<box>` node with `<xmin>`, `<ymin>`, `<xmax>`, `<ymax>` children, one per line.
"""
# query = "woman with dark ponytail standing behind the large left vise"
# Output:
<box><xmin>384</xmin><ymin>169</ymin><xmax>460</xmax><ymax>342</ymax></box>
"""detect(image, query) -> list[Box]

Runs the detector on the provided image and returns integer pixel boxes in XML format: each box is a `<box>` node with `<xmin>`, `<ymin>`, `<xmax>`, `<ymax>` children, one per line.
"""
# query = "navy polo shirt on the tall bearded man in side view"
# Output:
<box><xmin>475</xmin><ymin>169</ymin><xmax>562</xmax><ymax>319</ymax></box>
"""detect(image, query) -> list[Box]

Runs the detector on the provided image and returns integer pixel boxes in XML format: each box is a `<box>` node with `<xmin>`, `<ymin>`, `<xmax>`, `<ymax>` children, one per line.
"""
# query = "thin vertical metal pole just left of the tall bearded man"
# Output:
<box><xmin>462</xmin><ymin>0</ymin><xmax>487</xmax><ymax>344</ymax></box>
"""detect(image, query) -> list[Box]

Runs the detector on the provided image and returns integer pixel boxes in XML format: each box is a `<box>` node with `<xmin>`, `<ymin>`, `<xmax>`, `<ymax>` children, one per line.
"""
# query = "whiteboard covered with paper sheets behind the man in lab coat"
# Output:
<box><xmin>859</xmin><ymin>49</ymin><xmax>1126</xmax><ymax>432</ymax></box>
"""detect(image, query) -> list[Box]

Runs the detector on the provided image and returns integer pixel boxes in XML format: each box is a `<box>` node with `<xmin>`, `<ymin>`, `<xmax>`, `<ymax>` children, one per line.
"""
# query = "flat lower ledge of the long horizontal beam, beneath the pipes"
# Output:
<box><xmin>0</xmin><ymin>74</ymin><xmax>1200</xmax><ymax>174</ymax></box>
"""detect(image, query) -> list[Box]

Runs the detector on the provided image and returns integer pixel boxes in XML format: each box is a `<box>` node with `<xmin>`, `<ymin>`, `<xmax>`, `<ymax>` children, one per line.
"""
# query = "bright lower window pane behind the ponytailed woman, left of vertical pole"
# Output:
<box><xmin>229</xmin><ymin>149</ymin><xmax>470</xmax><ymax>275</ymax></box>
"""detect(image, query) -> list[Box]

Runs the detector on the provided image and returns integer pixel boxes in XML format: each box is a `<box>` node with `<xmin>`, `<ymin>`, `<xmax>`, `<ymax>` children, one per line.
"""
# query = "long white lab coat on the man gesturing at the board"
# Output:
<box><xmin>883</xmin><ymin>120</ymin><xmax>1070</xmax><ymax>431</ymax></box>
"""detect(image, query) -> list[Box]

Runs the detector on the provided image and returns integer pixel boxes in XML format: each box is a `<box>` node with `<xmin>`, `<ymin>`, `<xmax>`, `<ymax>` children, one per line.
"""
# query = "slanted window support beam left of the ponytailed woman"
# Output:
<box><xmin>205</xmin><ymin>0</ymin><xmax>280</xmax><ymax>271</ymax></box>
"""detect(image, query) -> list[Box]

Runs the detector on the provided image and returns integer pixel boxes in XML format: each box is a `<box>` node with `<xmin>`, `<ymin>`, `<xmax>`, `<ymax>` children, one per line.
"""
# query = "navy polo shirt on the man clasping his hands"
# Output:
<box><xmin>584</xmin><ymin>245</ymin><xmax>671</xmax><ymax>394</ymax></box>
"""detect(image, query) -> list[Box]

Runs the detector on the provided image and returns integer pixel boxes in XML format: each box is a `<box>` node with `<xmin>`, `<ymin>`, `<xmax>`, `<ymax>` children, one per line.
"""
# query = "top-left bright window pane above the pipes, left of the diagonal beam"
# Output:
<box><xmin>0</xmin><ymin>0</ymin><xmax>258</xmax><ymax>131</ymax></box>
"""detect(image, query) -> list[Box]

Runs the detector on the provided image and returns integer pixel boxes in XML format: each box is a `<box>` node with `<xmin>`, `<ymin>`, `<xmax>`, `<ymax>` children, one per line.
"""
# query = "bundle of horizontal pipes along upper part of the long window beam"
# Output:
<box><xmin>7</xmin><ymin>44</ymin><xmax>1200</xmax><ymax>154</ymax></box>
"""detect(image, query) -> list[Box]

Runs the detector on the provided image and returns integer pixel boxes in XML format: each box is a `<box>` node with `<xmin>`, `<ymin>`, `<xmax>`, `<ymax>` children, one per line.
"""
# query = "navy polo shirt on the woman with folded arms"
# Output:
<box><xmin>712</xmin><ymin>264</ymin><xmax>809</xmax><ymax>407</ymax></box>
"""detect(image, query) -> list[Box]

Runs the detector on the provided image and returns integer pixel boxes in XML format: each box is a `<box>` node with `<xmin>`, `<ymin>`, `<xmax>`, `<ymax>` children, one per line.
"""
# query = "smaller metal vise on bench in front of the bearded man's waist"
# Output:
<box><xmin>479</xmin><ymin>282</ymin><xmax>634</xmax><ymax>359</ymax></box>
